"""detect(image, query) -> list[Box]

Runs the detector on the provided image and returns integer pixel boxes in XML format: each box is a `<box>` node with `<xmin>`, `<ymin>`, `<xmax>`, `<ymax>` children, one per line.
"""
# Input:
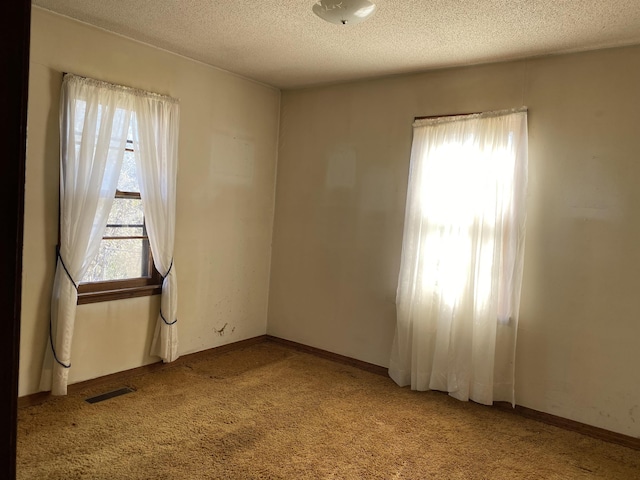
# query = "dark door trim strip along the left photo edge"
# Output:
<box><xmin>0</xmin><ymin>0</ymin><xmax>31</xmax><ymax>479</ymax></box>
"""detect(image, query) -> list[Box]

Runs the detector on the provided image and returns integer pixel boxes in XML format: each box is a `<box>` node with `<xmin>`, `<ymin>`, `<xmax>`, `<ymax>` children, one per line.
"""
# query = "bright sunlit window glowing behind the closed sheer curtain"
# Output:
<box><xmin>414</xmin><ymin>131</ymin><xmax>515</xmax><ymax>323</ymax></box>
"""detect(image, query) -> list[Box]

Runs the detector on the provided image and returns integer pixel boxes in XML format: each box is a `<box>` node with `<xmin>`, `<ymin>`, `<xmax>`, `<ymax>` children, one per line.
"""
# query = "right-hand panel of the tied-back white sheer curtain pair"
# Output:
<box><xmin>133</xmin><ymin>95</ymin><xmax>180</xmax><ymax>362</ymax></box>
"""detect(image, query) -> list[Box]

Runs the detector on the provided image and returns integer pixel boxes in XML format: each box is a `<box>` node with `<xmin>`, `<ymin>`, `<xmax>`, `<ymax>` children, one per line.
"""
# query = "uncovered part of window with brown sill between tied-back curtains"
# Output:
<box><xmin>78</xmin><ymin>129</ymin><xmax>162</xmax><ymax>305</ymax></box>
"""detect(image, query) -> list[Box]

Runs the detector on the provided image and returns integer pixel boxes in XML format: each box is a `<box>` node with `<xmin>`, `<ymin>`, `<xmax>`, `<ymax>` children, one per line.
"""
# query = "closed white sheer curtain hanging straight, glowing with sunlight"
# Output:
<box><xmin>389</xmin><ymin>109</ymin><xmax>527</xmax><ymax>405</ymax></box>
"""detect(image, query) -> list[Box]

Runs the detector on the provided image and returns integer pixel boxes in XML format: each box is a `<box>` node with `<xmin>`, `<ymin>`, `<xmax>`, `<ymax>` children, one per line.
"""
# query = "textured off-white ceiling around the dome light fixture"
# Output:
<box><xmin>33</xmin><ymin>0</ymin><xmax>640</xmax><ymax>89</ymax></box>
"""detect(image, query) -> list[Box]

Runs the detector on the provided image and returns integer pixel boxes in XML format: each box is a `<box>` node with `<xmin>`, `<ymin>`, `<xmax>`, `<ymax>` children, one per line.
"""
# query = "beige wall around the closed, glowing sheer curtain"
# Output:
<box><xmin>268</xmin><ymin>47</ymin><xmax>640</xmax><ymax>437</ymax></box>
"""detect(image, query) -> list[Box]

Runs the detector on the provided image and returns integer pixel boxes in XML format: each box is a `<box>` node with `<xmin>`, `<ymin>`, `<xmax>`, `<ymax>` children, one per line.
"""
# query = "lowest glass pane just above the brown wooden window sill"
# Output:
<box><xmin>82</xmin><ymin>239</ymin><xmax>149</xmax><ymax>282</ymax></box>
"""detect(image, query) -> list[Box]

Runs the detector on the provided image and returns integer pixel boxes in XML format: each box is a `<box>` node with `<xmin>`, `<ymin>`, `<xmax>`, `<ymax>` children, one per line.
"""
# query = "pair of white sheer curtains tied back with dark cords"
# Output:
<box><xmin>40</xmin><ymin>75</ymin><xmax>178</xmax><ymax>395</ymax></box>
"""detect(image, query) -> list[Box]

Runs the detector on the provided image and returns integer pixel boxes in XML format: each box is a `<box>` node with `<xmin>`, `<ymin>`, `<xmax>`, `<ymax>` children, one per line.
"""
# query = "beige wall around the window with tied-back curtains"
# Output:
<box><xmin>20</xmin><ymin>8</ymin><xmax>280</xmax><ymax>395</ymax></box>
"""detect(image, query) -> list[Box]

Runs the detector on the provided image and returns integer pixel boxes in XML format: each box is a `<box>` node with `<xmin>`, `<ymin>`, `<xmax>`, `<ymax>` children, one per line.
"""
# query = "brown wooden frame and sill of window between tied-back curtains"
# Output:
<box><xmin>74</xmin><ymin>141</ymin><xmax>163</xmax><ymax>305</ymax></box>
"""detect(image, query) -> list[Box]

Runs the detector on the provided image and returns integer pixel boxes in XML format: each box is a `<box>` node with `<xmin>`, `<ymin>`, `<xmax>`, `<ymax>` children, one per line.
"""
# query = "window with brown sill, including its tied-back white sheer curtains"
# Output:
<box><xmin>47</xmin><ymin>74</ymin><xmax>180</xmax><ymax>395</ymax></box>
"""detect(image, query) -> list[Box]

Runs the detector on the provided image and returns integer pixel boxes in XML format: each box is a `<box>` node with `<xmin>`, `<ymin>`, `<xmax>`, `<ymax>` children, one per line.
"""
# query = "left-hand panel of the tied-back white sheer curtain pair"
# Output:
<box><xmin>40</xmin><ymin>75</ymin><xmax>132</xmax><ymax>395</ymax></box>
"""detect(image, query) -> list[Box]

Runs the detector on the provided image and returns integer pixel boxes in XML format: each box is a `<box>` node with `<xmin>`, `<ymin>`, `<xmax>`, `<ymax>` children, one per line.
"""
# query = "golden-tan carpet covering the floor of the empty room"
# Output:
<box><xmin>18</xmin><ymin>342</ymin><xmax>640</xmax><ymax>480</ymax></box>
